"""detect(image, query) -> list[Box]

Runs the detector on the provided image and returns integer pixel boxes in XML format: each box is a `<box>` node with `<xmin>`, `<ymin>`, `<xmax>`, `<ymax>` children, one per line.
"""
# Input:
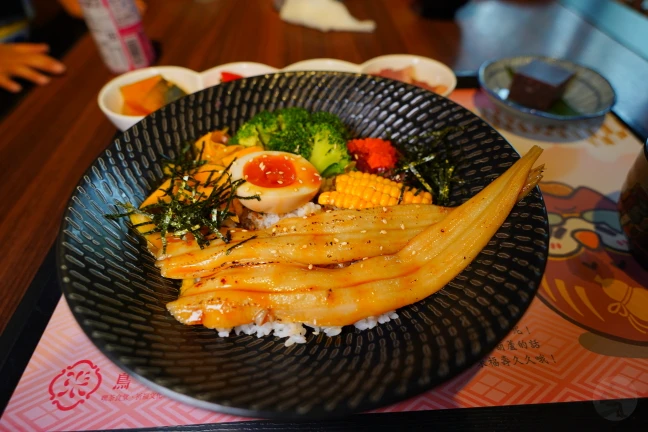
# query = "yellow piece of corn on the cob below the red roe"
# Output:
<box><xmin>318</xmin><ymin>171</ymin><xmax>432</xmax><ymax>209</ymax></box>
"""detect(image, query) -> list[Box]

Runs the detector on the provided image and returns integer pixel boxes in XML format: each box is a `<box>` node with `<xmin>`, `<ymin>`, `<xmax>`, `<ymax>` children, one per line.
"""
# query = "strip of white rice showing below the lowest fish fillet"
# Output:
<box><xmin>216</xmin><ymin>311</ymin><xmax>398</xmax><ymax>347</ymax></box>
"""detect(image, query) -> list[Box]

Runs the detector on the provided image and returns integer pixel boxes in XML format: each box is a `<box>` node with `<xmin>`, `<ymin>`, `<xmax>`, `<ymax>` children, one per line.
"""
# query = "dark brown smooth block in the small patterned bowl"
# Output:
<box><xmin>509</xmin><ymin>60</ymin><xmax>574</xmax><ymax>111</ymax></box>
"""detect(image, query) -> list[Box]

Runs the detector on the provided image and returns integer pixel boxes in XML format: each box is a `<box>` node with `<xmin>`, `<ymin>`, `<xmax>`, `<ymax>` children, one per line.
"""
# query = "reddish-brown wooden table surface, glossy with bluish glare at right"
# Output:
<box><xmin>0</xmin><ymin>0</ymin><xmax>648</xmax><ymax>332</ymax></box>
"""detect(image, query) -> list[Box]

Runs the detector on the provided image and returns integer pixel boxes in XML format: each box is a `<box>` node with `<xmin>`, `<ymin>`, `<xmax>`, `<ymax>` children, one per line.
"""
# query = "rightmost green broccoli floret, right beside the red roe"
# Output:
<box><xmin>308</xmin><ymin>122</ymin><xmax>351</xmax><ymax>177</ymax></box>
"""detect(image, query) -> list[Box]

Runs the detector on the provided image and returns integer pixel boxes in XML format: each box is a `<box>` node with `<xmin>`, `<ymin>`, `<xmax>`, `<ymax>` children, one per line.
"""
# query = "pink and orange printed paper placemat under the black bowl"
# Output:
<box><xmin>0</xmin><ymin>90</ymin><xmax>648</xmax><ymax>431</ymax></box>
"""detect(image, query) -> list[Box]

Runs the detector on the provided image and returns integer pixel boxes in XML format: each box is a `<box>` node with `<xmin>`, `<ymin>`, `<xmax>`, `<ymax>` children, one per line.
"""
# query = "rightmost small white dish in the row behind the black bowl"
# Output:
<box><xmin>360</xmin><ymin>54</ymin><xmax>457</xmax><ymax>96</ymax></box>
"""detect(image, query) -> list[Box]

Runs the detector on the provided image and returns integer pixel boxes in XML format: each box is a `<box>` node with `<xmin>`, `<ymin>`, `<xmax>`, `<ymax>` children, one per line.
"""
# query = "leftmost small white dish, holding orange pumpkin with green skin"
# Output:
<box><xmin>97</xmin><ymin>66</ymin><xmax>203</xmax><ymax>131</ymax></box>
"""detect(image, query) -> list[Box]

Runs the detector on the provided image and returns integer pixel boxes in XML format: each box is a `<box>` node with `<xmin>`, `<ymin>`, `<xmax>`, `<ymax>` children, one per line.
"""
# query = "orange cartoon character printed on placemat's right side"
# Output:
<box><xmin>538</xmin><ymin>183</ymin><xmax>648</xmax><ymax>345</ymax></box>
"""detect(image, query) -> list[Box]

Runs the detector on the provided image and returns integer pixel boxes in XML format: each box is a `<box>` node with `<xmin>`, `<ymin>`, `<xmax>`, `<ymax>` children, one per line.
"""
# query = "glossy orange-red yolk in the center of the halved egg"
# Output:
<box><xmin>243</xmin><ymin>155</ymin><xmax>297</xmax><ymax>188</ymax></box>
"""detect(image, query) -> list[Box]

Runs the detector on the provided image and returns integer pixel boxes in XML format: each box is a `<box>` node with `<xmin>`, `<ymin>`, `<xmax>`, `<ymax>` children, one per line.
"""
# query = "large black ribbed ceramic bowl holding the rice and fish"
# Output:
<box><xmin>57</xmin><ymin>72</ymin><xmax>548</xmax><ymax>418</ymax></box>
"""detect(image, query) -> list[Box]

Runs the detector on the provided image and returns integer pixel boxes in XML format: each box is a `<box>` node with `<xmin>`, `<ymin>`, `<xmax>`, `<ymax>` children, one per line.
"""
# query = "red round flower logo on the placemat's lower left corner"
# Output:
<box><xmin>49</xmin><ymin>360</ymin><xmax>101</xmax><ymax>411</ymax></box>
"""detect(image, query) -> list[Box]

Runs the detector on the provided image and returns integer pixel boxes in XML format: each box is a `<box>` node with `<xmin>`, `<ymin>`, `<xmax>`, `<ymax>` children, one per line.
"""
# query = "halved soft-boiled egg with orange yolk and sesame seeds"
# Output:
<box><xmin>230</xmin><ymin>151</ymin><xmax>322</xmax><ymax>214</ymax></box>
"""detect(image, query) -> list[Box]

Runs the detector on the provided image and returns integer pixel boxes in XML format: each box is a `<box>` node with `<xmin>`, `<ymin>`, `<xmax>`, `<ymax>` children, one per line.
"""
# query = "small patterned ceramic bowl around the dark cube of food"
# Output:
<box><xmin>479</xmin><ymin>56</ymin><xmax>616</xmax><ymax>124</ymax></box>
